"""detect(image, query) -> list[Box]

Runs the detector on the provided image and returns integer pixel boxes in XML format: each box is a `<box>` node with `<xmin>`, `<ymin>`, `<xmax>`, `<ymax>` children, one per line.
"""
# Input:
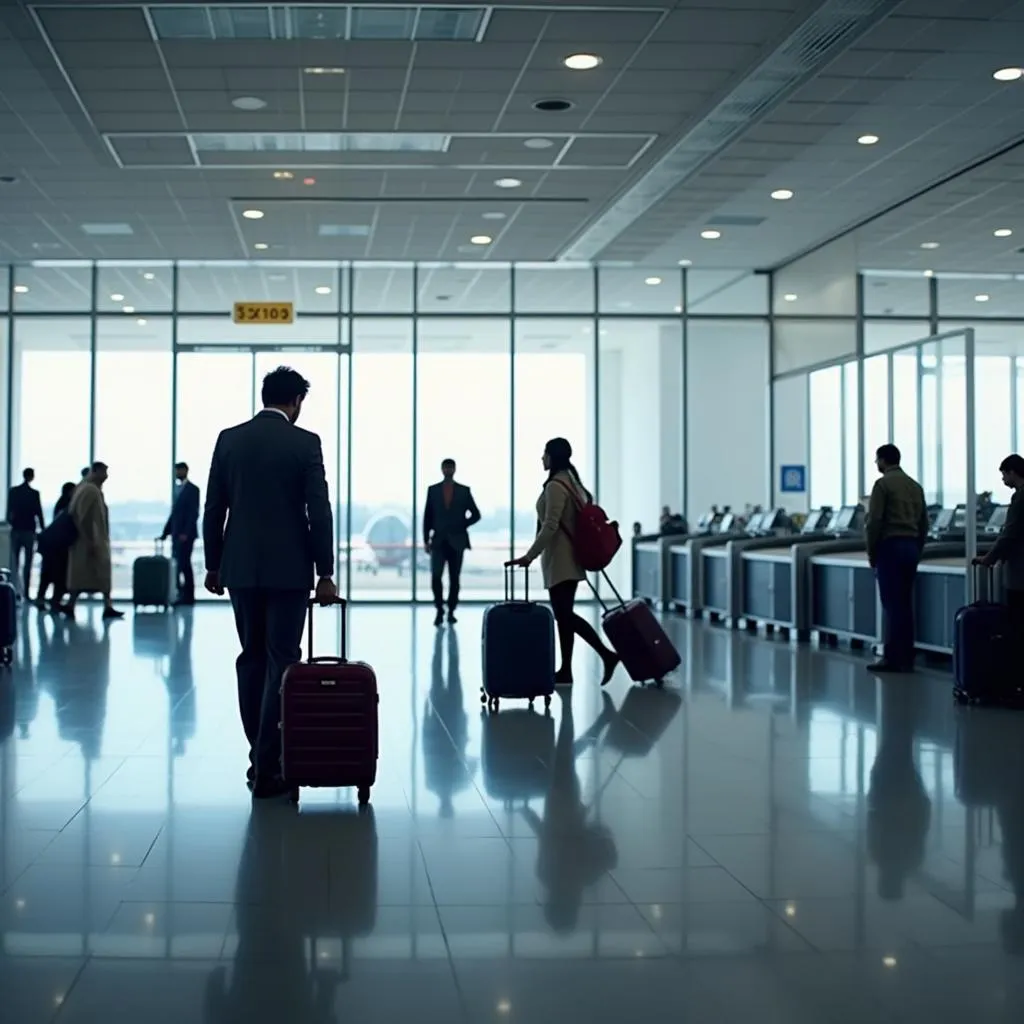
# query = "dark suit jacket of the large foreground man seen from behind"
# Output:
<box><xmin>203</xmin><ymin>410</ymin><xmax>334</xmax><ymax>592</ymax></box>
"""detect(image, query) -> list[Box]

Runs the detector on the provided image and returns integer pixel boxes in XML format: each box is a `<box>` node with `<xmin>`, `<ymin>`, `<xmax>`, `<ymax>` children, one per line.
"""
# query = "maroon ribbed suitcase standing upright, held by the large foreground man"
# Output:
<box><xmin>281</xmin><ymin>598</ymin><xmax>379</xmax><ymax>804</ymax></box>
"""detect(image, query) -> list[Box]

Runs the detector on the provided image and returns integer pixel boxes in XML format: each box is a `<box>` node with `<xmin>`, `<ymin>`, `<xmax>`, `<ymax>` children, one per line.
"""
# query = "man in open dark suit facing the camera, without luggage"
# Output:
<box><xmin>423</xmin><ymin>459</ymin><xmax>480</xmax><ymax>626</ymax></box>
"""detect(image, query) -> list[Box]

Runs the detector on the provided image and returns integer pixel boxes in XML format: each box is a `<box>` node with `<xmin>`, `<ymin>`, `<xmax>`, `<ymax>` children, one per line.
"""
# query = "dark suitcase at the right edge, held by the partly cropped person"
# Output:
<box><xmin>953</xmin><ymin>566</ymin><xmax>1024</xmax><ymax>708</ymax></box>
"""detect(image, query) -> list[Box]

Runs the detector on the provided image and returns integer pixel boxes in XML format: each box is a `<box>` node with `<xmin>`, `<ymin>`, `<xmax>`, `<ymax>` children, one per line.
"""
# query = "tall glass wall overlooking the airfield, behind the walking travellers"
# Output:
<box><xmin>0</xmin><ymin>260</ymin><xmax>704</xmax><ymax>601</ymax></box>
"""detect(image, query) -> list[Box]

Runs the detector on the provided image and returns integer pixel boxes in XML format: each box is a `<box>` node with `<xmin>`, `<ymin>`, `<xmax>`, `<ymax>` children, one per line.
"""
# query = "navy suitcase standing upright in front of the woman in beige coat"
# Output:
<box><xmin>480</xmin><ymin>567</ymin><xmax>555</xmax><ymax>711</ymax></box>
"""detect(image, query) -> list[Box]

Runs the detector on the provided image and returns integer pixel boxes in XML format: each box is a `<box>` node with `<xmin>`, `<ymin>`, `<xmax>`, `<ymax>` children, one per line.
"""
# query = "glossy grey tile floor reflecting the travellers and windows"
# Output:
<box><xmin>0</xmin><ymin>606</ymin><xmax>1024</xmax><ymax>1024</ymax></box>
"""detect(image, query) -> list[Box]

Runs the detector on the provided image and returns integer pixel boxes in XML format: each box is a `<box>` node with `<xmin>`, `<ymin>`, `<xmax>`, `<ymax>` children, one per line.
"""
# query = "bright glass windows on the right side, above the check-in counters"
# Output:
<box><xmin>776</xmin><ymin>273</ymin><xmax>1024</xmax><ymax>507</ymax></box>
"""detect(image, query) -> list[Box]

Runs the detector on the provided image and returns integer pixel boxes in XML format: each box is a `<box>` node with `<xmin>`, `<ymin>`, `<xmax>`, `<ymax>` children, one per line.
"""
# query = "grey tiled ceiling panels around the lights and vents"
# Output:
<box><xmin>0</xmin><ymin>0</ymin><xmax>1024</xmax><ymax>271</ymax></box>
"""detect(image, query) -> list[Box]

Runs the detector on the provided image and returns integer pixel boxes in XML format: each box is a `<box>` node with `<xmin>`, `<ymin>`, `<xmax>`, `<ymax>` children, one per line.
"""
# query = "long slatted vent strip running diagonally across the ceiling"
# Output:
<box><xmin>561</xmin><ymin>0</ymin><xmax>900</xmax><ymax>260</ymax></box>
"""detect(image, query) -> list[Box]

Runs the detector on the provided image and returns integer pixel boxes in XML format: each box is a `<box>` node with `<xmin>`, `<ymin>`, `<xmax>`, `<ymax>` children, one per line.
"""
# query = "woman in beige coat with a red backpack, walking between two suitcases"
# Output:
<box><xmin>510</xmin><ymin>437</ymin><xmax>620</xmax><ymax>686</ymax></box>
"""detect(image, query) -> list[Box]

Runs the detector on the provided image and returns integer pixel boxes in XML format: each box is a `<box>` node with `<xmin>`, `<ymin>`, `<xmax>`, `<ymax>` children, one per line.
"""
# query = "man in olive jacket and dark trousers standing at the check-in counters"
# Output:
<box><xmin>864</xmin><ymin>444</ymin><xmax>928</xmax><ymax>672</ymax></box>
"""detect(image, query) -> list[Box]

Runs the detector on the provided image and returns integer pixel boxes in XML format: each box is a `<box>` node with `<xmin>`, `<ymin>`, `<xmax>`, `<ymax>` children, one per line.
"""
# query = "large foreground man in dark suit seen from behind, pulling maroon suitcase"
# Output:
<box><xmin>203</xmin><ymin>367</ymin><xmax>338</xmax><ymax>798</ymax></box>
